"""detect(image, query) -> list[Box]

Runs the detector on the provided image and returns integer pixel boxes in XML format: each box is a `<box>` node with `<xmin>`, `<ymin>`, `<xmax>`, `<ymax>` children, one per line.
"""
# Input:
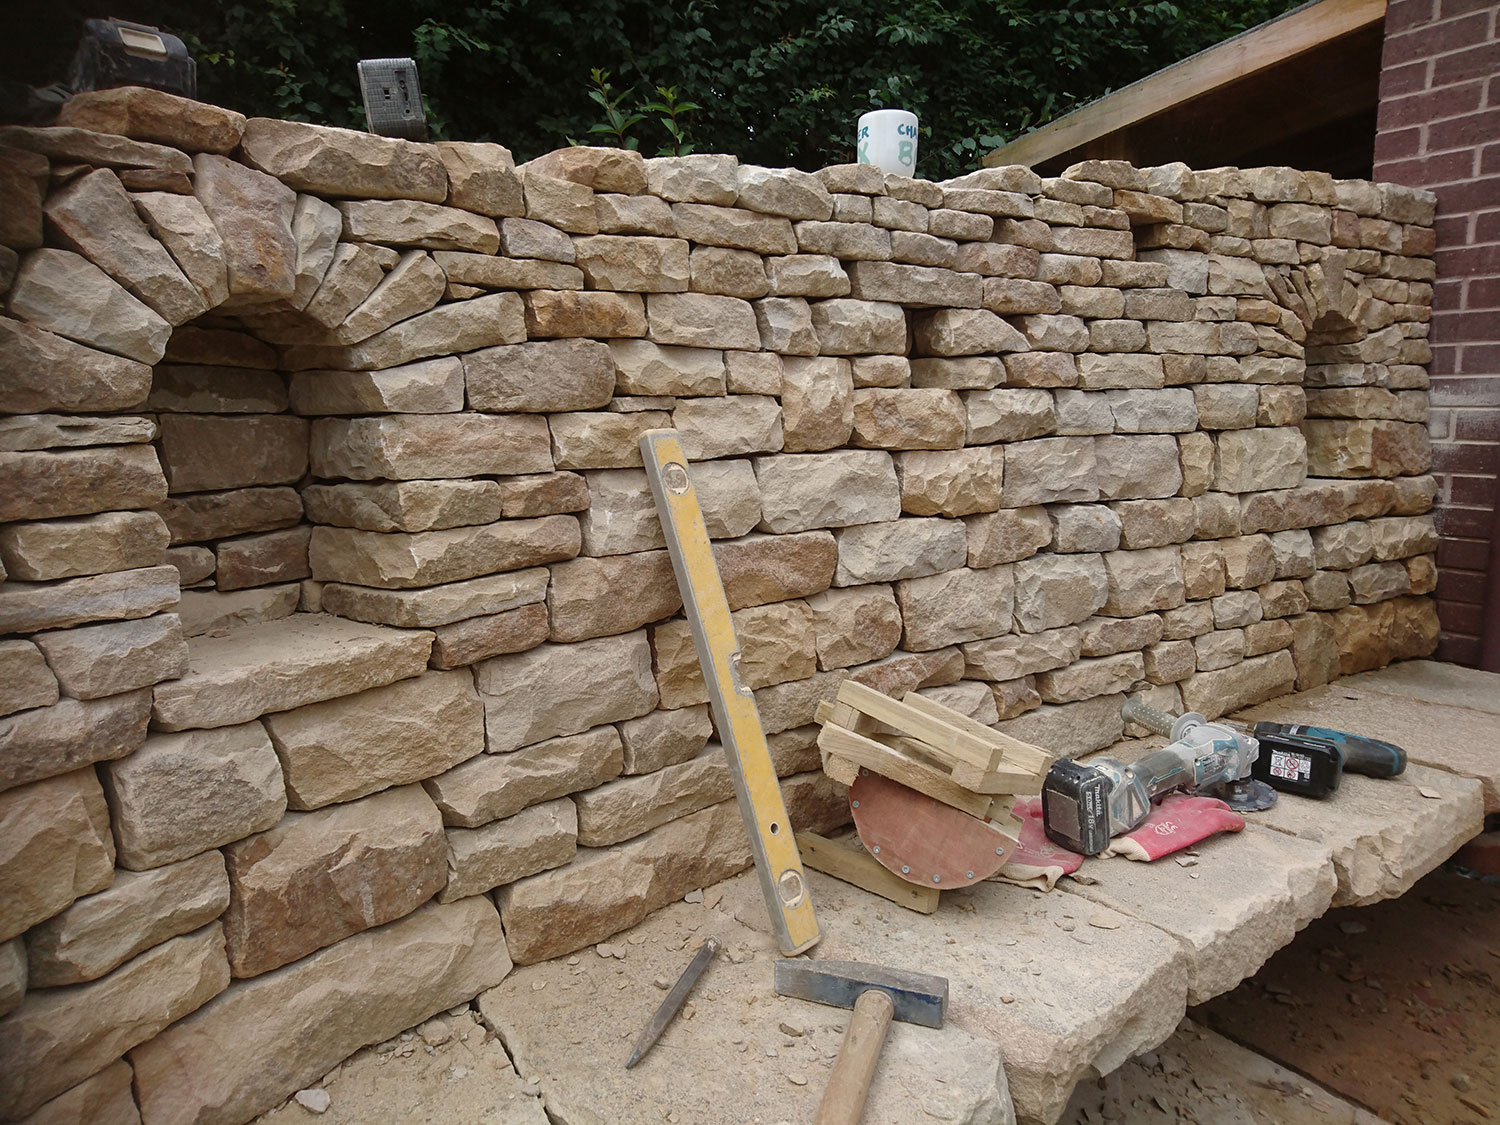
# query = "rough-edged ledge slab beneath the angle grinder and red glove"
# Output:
<box><xmin>1058</xmin><ymin>825</ymin><xmax>1338</xmax><ymax>1004</ymax></box>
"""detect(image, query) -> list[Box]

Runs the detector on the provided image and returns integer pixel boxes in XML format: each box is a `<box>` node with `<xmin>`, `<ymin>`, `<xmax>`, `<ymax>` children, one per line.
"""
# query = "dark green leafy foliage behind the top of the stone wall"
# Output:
<box><xmin>161</xmin><ymin>0</ymin><xmax>1295</xmax><ymax>179</ymax></box>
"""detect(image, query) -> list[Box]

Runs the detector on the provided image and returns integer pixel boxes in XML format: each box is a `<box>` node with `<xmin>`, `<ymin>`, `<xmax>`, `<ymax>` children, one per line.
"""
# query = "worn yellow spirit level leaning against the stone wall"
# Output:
<box><xmin>641</xmin><ymin>429</ymin><xmax>821</xmax><ymax>957</ymax></box>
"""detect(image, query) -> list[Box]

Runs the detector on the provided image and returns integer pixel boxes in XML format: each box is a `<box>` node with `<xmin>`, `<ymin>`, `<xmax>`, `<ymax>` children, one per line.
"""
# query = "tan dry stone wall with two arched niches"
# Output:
<box><xmin>0</xmin><ymin>83</ymin><xmax>1437</xmax><ymax>1122</ymax></box>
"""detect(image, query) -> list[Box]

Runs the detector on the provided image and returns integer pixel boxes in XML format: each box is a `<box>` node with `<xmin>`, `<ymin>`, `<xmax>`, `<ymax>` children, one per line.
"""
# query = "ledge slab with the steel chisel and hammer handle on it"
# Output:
<box><xmin>479</xmin><ymin>900</ymin><xmax>1016</xmax><ymax>1125</ymax></box>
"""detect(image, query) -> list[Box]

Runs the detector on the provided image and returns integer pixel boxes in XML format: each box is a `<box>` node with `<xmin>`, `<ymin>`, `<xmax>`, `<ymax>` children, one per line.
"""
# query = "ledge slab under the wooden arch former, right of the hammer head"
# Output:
<box><xmin>705</xmin><ymin>860</ymin><xmax>1190</xmax><ymax>1122</ymax></box>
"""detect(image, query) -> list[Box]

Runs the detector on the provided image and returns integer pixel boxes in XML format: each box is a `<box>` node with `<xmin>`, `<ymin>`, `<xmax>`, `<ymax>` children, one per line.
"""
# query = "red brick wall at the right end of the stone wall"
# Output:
<box><xmin>1376</xmin><ymin>0</ymin><xmax>1500</xmax><ymax>671</ymax></box>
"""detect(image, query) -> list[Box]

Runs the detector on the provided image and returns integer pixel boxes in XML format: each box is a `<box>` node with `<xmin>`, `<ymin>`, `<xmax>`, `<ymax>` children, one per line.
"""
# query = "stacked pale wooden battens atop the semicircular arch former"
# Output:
<box><xmin>818</xmin><ymin>680</ymin><xmax>1053</xmax><ymax>846</ymax></box>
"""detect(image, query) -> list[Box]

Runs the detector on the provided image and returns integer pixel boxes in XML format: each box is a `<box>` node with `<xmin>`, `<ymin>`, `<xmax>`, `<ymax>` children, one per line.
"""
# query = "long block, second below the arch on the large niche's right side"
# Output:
<box><xmin>312</xmin><ymin>414</ymin><xmax>554</xmax><ymax>480</ymax></box>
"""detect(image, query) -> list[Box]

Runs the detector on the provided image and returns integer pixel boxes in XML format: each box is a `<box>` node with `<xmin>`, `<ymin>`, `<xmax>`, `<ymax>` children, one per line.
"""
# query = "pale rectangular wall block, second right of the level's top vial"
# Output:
<box><xmin>753</xmin><ymin>450</ymin><xmax>902</xmax><ymax>533</ymax></box>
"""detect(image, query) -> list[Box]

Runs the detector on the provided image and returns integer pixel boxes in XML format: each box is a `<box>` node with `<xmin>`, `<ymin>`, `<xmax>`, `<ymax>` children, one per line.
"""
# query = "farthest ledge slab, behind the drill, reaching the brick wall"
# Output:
<box><xmin>1236</xmin><ymin>662</ymin><xmax>1500</xmax><ymax>816</ymax></box>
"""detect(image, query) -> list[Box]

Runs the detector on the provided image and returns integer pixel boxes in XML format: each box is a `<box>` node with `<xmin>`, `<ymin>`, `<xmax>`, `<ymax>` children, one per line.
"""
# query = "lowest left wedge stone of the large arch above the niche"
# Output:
<box><xmin>8</xmin><ymin>250</ymin><xmax>171</xmax><ymax>363</ymax></box>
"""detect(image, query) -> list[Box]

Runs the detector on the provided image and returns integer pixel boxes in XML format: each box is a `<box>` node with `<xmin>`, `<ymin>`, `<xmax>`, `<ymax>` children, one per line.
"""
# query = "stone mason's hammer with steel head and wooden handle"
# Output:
<box><xmin>776</xmin><ymin>960</ymin><xmax>948</xmax><ymax>1125</ymax></box>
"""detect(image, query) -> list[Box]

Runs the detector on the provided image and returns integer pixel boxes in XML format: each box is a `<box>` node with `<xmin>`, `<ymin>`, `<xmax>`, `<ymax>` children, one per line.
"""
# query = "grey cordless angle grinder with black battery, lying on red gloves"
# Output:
<box><xmin>1041</xmin><ymin>699</ymin><xmax>1277</xmax><ymax>855</ymax></box>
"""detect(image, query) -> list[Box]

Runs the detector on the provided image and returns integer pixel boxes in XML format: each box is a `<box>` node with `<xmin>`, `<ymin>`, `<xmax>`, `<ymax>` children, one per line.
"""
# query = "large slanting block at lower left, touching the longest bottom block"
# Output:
<box><xmin>0</xmin><ymin>926</ymin><xmax>230</xmax><ymax>1118</ymax></box>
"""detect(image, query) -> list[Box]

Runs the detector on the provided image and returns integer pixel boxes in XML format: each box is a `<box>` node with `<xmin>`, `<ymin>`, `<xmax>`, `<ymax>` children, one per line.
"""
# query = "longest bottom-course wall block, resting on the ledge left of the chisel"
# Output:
<box><xmin>131</xmin><ymin>897</ymin><xmax>510</xmax><ymax>1121</ymax></box>
